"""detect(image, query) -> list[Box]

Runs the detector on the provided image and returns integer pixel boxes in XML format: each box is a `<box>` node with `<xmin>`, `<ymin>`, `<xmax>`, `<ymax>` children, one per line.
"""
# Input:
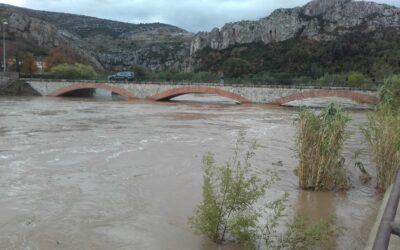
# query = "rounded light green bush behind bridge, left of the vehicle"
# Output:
<box><xmin>49</xmin><ymin>63</ymin><xmax>97</xmax><ymax>79</ymax></box>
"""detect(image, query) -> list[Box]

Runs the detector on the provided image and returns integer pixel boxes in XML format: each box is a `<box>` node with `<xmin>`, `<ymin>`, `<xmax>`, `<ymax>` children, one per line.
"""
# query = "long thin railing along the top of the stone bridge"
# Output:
<box><xmin>21</xmin><ymin>78</ymin><xmax>378</xmax><ymax>91</ymax></box>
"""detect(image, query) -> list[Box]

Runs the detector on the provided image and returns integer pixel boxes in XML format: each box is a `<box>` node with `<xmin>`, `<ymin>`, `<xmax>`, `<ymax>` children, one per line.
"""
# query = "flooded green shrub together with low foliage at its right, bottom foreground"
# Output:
<box><xmin>189</xmin><ymin>131</ymin><xmax>341</xmax><ymax>249</ymax></box>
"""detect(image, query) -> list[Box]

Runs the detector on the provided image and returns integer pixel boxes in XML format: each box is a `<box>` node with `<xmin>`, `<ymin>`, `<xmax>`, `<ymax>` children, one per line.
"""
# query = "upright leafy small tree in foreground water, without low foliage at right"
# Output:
<box><xmin>189</xmin><ymin>131</ymin><xmax>287</xmax><ymax>249</ymax></box>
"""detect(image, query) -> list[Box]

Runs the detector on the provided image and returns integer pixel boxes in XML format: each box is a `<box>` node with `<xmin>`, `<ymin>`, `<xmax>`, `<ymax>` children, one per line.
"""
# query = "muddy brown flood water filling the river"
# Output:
<box><xmin>0</xmin><ymin>94</ymin><xmax>381</xmax><ymax>250</ymax></box>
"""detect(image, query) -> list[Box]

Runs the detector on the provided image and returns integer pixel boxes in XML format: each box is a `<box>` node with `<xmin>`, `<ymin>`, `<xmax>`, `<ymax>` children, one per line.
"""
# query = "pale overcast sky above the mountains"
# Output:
<box><xmin>0</xmin><ymin>0</ymin><xmax>400</xmax><ymax>32</ymax></box>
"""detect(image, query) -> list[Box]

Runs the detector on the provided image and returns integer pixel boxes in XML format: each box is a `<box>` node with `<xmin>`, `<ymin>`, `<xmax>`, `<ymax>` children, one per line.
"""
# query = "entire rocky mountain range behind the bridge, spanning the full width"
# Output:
<box><xmin>0</xmin><ymin>0</ymin><xmax>400</xmax><ymax>77</ymax></box>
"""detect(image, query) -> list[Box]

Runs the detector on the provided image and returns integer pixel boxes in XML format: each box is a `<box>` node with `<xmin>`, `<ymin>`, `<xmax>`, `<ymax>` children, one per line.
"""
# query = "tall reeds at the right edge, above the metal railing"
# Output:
<box><xmin>361</xmin><ymin>76</ymin><xmax>400</xmax><ymax>192</ymax></box>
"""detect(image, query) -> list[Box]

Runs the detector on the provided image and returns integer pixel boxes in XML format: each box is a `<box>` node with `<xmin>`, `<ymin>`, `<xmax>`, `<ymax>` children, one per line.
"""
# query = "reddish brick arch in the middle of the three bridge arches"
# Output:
<box><xmin>150</xmin><ymin>86</ymin><xmax>252</xmax><ymax>103</ymax></box>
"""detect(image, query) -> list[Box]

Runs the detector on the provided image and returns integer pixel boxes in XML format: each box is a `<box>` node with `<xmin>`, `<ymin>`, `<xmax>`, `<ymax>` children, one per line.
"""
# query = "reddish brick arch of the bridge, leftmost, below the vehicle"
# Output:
<box><xmin>48</xmin><ymin>83</ymin><xmax>136</xmax><ymax>99</ymax></box>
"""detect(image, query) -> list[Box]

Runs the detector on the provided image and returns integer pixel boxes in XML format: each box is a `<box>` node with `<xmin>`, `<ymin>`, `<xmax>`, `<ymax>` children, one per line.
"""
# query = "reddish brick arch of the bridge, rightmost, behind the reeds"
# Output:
<box><xmin>270</xmin><ymin>89</ymin><xmax>378</xmax><ymax>105</ymax></box>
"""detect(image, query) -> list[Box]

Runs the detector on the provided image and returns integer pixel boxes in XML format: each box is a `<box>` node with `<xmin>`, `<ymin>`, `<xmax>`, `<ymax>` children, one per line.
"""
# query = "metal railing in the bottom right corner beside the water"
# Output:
<box><xmin>372</xmin><ymin>171</ymin><xmax>400</xmax><ymax>250</ymax></box>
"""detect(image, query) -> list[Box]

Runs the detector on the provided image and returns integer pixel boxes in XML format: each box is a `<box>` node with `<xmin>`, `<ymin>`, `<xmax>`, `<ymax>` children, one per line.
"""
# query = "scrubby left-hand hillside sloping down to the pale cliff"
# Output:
<box><xmin>0</xmin><ymin>4</ymin><xmax>193</xmax><ymax>70</ymax></box>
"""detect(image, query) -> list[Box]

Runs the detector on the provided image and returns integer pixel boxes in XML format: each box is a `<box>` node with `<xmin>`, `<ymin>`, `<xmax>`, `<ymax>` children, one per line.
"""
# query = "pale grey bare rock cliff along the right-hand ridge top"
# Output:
<box><xmin>190</xmin><ymin>0</ymin><xmax>400</xmax><ymax>55</ymax></box>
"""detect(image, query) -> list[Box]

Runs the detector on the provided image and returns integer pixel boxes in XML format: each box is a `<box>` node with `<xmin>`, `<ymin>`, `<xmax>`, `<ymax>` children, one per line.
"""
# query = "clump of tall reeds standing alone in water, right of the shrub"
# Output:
<box><xmin>297</xmin><ymin>104</ymin><xmax>349</xmax><ymax>191</ymax></box>
